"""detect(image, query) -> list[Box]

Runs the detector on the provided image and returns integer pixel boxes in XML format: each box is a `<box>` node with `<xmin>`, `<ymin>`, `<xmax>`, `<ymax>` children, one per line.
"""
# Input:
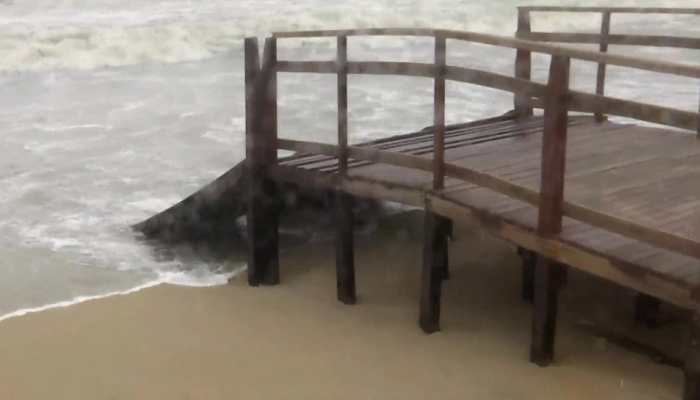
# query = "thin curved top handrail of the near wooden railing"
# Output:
<box><xmin>273</xmin><ymin>28</ymin><xmax>700</xmax><ymax>78</ymax></box>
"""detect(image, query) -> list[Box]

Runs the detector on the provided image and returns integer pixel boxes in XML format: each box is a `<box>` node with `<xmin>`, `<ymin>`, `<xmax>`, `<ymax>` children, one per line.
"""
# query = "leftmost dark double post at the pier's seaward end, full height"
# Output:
<box><xmin>244</xmin><ymin>38</ymin><xmax>279</xmax><ymax>286</ymax></box>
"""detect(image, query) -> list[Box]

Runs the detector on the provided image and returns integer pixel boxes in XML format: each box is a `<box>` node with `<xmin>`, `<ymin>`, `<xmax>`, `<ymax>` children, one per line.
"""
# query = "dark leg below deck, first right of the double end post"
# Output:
<box><xmin>334</xmin><ymin>191</ymin><xmax>357</xmax><ymax>304</ymax></box>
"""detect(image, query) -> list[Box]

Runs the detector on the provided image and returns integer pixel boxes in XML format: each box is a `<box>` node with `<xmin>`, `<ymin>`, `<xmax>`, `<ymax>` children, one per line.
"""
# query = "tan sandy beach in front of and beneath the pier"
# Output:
<box><xmin>0</xmin><ymin>214</ymin><xmax>682</xmax><ymax>400</ymax></box>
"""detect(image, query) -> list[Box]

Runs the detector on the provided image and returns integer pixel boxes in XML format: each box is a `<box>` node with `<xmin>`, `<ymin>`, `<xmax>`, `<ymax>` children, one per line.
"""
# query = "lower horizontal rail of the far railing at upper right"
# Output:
<box><xmin>519</xmin><ymin>32</ymin><xmax>700</xmax><ymax>49</ymax></box>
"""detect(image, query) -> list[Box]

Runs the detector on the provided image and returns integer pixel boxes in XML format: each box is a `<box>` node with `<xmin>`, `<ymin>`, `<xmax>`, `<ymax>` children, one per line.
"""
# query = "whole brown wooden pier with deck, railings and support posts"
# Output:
<box><xmin>141</xmin><ymin>7</ymin><xmax>700</xmax><ymax>399</ymax></box>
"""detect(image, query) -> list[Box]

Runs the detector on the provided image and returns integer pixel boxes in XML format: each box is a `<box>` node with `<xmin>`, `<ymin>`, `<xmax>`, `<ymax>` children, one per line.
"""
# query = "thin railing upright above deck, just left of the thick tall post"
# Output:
<box><xmin>433</xmin><ymin>36</ymin><xmax>447</xmax><ymax>190</ymax></box>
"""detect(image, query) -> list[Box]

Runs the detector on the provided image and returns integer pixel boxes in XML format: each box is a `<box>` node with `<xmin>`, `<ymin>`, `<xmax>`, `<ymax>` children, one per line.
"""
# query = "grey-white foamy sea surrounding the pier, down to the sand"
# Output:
<box><xmin>0</xmin><ymin>0</ymin><xmax>700</xmax><ymax>319</ymax></box>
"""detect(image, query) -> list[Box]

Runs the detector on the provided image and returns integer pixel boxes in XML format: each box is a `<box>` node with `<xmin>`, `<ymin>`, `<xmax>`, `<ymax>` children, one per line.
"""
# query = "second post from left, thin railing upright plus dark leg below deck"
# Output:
<box><xmin>334</xmin><ymin>36</ymin><xmax>357</xmax><ymax>304</ymax></box>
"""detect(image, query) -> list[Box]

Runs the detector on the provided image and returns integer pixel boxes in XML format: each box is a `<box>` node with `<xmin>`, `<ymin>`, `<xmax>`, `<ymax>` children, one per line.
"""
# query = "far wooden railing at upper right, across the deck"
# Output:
<box><xmin>515</xmin><ymin>7</ymin><xmax>700</xmax><ymax>120</ymax></box>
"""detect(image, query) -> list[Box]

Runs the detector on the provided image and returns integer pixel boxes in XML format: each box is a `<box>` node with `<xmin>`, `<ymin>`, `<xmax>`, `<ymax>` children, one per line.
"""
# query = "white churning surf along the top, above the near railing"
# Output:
<box><xmin>0</xmin><ymin>0</ymin><xmax>692</xmax><ymax>71</ymax></box>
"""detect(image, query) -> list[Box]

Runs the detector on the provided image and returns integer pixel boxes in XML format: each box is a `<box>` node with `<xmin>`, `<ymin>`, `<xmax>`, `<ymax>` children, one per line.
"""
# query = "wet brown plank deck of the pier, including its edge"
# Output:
<box><xmin>280</xmin><ymin>117</ymin><xmax>700</xmax><ymax>306</ymax></box>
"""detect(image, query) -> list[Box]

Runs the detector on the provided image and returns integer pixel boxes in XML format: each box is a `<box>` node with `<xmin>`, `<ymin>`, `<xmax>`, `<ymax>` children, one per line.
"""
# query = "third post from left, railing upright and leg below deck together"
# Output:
<box><xmin>419</xmin><ymin>36</ymin><xmax>447</xmax><ymax>333</ymax></box>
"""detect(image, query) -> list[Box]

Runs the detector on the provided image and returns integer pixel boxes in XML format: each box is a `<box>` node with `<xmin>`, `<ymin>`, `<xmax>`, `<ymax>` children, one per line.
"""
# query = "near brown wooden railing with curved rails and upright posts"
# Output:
<box><xmin>245</xmin><ymin>29</ymin><xmax>700</xmax><ymax>258</ymax></box>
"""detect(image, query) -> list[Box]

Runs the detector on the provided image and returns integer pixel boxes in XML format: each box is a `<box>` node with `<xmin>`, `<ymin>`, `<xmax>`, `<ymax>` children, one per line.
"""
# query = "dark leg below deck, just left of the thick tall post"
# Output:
<box><xmin>419</xmin><ymin>208</ymin><xmax>443</xmax><ymax>333</ymax></box>
